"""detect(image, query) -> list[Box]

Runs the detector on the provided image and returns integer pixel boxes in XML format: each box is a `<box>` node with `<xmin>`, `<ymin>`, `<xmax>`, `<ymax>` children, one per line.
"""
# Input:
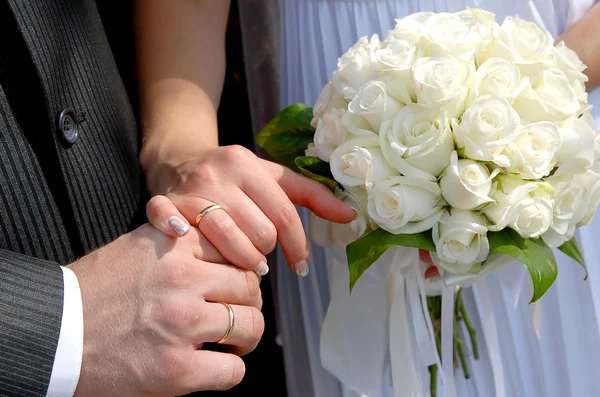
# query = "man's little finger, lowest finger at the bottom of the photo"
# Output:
<box><xmin>181</xmin><ymin>350</ymin><xmax>246</xmax><ymax>393</ymax></box>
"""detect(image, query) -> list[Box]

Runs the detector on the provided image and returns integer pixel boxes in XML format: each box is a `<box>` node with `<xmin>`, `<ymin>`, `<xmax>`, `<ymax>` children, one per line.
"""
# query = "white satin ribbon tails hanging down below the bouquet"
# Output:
<box><xmin>310</xmin><ymin>217</ymin><xmax>472</xmax><ymax>397</ymax></box>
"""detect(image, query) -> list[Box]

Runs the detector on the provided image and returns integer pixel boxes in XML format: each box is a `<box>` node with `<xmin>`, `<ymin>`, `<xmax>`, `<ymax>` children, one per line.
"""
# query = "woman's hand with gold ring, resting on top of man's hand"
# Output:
<box><xmin>147</xmin><ymin>146</ymin><xmax>355</xmax><ymax>276</ymax></box>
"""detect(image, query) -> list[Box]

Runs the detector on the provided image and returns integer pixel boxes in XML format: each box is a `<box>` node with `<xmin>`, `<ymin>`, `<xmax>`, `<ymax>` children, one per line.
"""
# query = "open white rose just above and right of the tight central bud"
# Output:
<box><xmin>452</xmin><ymin>97</ymin><xmax>520</xmax><ymax>167</ymax></box>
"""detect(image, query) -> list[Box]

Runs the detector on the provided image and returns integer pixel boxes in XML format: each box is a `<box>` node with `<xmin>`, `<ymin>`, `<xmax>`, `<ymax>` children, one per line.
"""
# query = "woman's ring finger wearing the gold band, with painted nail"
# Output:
<box><xmin>173</xmin><ymin>196</ymin><xmax>269</xmax><ymax>276</ymax></box>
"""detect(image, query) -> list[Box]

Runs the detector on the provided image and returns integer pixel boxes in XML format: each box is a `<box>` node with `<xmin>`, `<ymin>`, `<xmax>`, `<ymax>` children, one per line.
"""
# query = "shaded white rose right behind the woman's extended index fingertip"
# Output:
<box><xmin>331</xmin><ymin>187</ymin><xmax>370</xmax><ymax>249</ymax></box>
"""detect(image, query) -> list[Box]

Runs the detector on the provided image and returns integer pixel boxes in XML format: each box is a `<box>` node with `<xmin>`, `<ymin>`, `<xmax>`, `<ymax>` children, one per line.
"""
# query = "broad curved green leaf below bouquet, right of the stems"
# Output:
<box><xmin>488</xmin><ymin>228</ymin><xmax>558</xmax><ymax>303</ymax></box>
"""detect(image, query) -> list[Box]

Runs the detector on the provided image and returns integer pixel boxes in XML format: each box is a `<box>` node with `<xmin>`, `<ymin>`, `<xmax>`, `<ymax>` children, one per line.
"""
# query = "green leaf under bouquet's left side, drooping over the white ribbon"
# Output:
<box><xmin>346</xmin><ymin>229</ymin><xmax>435</xmax><ymax>293</ymax></box>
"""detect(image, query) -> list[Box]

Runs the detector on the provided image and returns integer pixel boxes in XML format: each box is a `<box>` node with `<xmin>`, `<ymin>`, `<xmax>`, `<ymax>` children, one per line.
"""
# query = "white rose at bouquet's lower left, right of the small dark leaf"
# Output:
<box><xmin>330</xmin><ymin>139</ymin><xmax>398</xmax><ymax>187</ymax></box>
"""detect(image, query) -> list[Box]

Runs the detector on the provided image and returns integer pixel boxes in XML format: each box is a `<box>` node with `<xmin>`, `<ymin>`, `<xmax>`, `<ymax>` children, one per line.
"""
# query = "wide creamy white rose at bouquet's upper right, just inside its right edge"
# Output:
<box><xmin>513</xmin><ymin>68</ymin><xmax>581</xmax><ymax>122</ymax></box>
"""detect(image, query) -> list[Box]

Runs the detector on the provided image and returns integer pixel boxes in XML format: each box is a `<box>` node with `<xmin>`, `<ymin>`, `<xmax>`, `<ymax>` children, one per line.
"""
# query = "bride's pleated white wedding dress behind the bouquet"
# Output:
<box><xmin>277</xmin><ymin>0</ymin><xmax>600</xmax><ymax>397</ymax></box>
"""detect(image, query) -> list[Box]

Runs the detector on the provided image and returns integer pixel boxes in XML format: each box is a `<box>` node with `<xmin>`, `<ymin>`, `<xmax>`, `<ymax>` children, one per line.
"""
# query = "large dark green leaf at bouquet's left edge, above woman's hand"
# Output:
<box><xmin>256</xmin><ymin>103</ymin><xmax>315</xmax><ymax>172</ymax></box>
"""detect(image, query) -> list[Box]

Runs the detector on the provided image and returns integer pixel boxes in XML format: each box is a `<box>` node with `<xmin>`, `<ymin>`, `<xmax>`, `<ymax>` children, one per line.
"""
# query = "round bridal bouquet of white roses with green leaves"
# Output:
<box><xmin>257</xmin><ymin>9</ymin><xmax>600</xmax><ymax>392</ymax></box>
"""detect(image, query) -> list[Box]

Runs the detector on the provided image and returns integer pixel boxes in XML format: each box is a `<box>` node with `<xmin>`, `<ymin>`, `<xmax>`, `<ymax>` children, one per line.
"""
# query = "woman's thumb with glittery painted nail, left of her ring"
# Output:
<box><xmin>146</xmin><ymin>196</ymin><xmax>190</xmax><ymax>237</ymax></box>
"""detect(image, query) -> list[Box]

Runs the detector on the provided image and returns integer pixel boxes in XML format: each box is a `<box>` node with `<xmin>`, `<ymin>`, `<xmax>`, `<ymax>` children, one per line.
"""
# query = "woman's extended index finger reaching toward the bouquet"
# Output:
<box><xmin>260</xmin><ymin>159</ymin><xmax>356</xmax><ymax>223</ymax></box>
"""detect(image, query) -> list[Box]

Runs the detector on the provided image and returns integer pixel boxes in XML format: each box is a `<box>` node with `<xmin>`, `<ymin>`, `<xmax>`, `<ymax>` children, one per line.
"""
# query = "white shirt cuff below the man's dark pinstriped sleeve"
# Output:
<box><xmin>46</xmin><ymin>267</ymin><xmax>83</xmax><ymax>397</ymax></box>
